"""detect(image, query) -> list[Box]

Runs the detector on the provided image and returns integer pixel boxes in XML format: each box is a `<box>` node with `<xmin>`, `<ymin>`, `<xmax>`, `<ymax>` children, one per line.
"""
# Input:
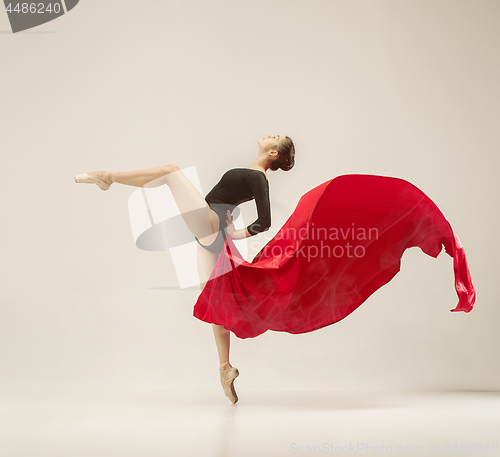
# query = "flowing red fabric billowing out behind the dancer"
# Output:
<box><xmin>193</xmin><ymin>175</ymin><xmax>476</xmax><ymax>338</ymax></box>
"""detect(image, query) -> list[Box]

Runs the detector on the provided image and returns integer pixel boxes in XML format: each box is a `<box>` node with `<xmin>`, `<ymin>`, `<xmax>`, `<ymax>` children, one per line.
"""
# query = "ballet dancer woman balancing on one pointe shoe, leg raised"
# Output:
<box><xmin>75</xmin><ymin>135</ymin><xmax>295</xmax><ymax>403</ymax></box>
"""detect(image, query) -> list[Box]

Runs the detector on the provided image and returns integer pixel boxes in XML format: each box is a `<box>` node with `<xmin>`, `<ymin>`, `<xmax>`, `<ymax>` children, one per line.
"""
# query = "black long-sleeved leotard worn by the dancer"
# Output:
<box><xmin>195</xmin><ymin>168</ymin><xmax>271</xmax><ymax>254</ymax></box>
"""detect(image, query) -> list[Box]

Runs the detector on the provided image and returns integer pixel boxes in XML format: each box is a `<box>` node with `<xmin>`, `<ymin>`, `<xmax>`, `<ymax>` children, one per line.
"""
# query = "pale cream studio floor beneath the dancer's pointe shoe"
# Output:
<box><xmin>0</xmin><ymin>390</ymin><xmax>500</xmax><ymax>457</ymax></box>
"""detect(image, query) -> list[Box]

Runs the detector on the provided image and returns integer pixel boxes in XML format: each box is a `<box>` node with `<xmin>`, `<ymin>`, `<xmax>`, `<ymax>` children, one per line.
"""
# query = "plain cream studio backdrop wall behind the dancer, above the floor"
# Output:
<box><xmin>0</xmin><ymin>0</ymin><xmax>500</xmax><ymax>392</ymax></box>
